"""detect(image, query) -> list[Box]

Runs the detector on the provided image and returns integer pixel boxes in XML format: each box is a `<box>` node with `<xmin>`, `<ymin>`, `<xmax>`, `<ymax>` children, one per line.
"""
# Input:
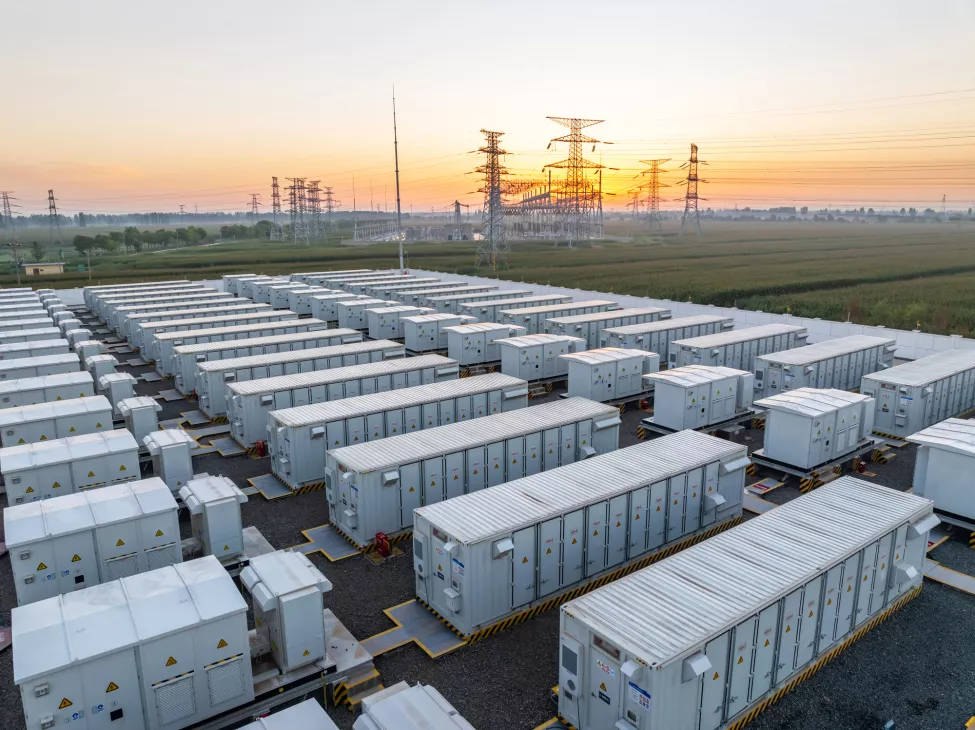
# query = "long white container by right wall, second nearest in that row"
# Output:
<box><xmin>755</xmin><ymin>335</ymin><xmax>897</xmax><ymax>396</ymax></box>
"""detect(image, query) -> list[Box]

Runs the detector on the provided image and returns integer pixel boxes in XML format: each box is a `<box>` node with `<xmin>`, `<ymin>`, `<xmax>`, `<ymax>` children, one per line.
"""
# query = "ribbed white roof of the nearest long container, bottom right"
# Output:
<box><xmin>564</xmin><ymin>477</ymin><xmax>932</xmax><ymax>668</ymax></box>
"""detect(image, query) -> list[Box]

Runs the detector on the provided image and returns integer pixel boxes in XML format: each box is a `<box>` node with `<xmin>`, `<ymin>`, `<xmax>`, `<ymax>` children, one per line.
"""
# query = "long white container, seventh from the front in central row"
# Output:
<box><xmin>173</xmin><ymin>326</ymin><xmax>362</xmax><ymax>395</ymax></box>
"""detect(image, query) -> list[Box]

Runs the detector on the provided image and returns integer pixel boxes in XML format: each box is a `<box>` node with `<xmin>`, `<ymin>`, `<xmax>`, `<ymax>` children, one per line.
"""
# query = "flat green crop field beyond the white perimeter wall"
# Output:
<box><xmin>0</xmin><ymin>221</ymin><xmax>975</xmax><ymax>335</ymax></box>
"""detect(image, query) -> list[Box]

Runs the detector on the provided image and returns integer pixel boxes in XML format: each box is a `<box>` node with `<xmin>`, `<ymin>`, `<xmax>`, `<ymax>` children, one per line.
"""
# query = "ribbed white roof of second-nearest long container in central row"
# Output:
<box><xmin>418</xmin><ymin>430</ymin><xmax>748</xmax><ymax>545</ymax></box>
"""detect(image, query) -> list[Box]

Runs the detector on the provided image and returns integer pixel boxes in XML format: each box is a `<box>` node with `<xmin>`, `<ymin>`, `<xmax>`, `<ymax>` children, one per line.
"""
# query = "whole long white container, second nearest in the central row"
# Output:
<box><xmin>413</xmin><ymin>431</ymin><xmax>750</xmax><ymax>636</ymax></box>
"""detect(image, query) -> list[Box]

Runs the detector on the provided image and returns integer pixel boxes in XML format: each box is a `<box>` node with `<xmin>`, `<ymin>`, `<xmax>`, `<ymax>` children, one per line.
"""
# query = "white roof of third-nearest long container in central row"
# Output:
<box><xmin>326</xmin><ymin>398</ymin><xmax>619</xmax><ymax>472</ymax></box>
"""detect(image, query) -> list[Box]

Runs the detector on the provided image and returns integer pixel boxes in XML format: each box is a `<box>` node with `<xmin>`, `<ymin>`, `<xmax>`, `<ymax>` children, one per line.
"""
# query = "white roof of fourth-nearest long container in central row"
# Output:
<box><xmin>269</xmin><ymin>373</ymin><xmax>528</xmax><ymax>428</ymax></box>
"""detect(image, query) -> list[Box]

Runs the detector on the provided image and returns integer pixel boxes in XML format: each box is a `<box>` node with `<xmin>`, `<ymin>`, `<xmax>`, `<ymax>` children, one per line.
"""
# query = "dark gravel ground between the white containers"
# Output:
<box><xmin>0</xmin><ymin>312</ymin><xmax>975</xmax><ymax>730</ymax></box>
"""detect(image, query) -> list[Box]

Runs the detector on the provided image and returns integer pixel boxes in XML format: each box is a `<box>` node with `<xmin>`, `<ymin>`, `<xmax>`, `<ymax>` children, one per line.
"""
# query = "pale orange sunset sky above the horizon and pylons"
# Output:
<box><xmin>0</xmin><ymin>0</ymin><xmax>975</xmax><ymax>213</ymax></box>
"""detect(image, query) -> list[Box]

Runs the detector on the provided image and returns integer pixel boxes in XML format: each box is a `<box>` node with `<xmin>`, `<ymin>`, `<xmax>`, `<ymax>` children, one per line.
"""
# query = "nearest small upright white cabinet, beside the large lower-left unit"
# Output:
<box><xmin>240</xmin><ymin>550</ymin><xmax>332</xmax><ymax>672</ymax></box>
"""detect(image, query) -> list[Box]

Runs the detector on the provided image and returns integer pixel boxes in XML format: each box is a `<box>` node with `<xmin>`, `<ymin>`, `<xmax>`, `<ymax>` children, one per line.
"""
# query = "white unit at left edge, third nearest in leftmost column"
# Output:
<box><xmin>0</xmin><ymin>429</ymin><xmax>140</xmax><ymax>504</ymax></box>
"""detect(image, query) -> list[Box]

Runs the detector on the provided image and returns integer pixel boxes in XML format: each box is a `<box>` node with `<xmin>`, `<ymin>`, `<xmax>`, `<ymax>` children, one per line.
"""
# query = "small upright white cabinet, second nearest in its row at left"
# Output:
<box><xmin>179</xmin><ymin>476</ymin><xmax>247</xmax><ymax>561</ymax></box>
